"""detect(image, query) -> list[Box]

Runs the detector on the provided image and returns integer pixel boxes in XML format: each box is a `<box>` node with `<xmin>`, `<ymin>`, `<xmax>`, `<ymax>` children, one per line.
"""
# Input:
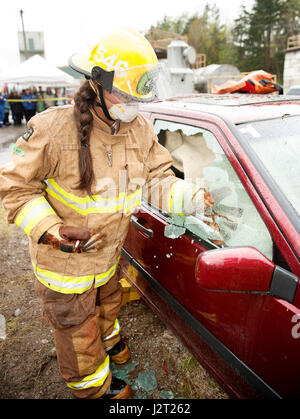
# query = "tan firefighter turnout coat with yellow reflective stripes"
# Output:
<box><xmin>0</xmin><ymin>105</ymin><xmax>182</xmax><ymax>293</ymax></box>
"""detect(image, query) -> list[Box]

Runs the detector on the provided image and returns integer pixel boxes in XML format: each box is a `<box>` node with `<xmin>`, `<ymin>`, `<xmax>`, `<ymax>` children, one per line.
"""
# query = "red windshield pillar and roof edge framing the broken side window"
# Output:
<box><xmin>143</xmin><ymin>110</ymin><xmax>300</xmax><ymax>275</ymax></box>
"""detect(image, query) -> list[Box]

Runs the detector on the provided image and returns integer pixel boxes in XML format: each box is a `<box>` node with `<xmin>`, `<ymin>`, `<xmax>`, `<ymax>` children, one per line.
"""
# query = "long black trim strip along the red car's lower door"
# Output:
<box><xmin>122</xmin><ymin>248</ymin><xmax>282</xmax><ymax>399</ymax></box>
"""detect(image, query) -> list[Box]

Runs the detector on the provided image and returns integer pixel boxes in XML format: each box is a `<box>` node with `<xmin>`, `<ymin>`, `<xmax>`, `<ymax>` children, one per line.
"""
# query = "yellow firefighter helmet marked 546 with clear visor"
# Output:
<box><xmin>69</xmin><ymin>27</ymin><xmax>159</xmax><ymax>101</ymax></box>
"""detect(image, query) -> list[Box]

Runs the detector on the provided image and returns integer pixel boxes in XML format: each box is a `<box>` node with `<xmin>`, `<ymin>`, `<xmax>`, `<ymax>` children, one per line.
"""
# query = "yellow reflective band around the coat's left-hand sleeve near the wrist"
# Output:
<box><xmin>15</xmin><ymin>197</ymin><xmax>55</xmax><ymax>235</ymax></box>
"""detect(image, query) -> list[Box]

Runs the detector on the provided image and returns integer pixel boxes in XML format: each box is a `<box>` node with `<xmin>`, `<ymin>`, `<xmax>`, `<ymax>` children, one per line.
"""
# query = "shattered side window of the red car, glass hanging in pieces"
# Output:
<box><xmin>154</xmin><ymin>120</ymin><xmax>273</xmax><ymax>260</ymax></box>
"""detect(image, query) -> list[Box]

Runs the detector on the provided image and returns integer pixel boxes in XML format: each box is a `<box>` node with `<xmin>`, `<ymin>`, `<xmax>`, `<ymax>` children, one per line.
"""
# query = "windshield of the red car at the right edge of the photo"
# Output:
<box><xmin>239</xmin><ymin>116</ymin><xmax>300</xmax><ymax>220</ymax></box>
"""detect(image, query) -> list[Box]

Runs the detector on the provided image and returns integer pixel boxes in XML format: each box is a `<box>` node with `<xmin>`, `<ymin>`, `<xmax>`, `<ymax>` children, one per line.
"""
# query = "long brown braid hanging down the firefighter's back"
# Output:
<box><xmin>74</xmin><ymin>81</ymin><xmax>96</xmax><ymax>196</ymax></box>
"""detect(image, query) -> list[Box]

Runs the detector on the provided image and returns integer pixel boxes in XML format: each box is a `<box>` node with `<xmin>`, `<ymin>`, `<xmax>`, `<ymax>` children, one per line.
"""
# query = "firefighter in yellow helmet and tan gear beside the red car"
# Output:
<box><xmin>0</xmin><ymin>28</ymin><xmax>211</xmax><ymax>398</ymax></box>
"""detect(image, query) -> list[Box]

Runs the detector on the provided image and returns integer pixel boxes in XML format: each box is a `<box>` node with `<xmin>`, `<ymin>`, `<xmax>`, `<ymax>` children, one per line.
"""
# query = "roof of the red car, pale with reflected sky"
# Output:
<box><xmin>141</xmin><ymin>93</ymin><xmax>300</xmax><ymax>124</ymax></box>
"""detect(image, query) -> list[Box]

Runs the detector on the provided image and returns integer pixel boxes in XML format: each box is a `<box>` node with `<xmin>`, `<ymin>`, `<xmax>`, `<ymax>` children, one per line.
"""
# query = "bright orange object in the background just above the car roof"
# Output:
<box><xmin>212</xmin><ymin>70</ymin><xmax>283</xmax><ymax>95</ymax></box>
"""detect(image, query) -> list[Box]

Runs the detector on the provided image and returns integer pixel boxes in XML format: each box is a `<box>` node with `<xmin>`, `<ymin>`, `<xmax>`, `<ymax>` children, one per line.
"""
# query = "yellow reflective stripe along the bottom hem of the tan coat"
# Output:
<box><xmin>32</xmin><ymin>260</ymin><xmax>119</xmax><ymax>294</ymax></box>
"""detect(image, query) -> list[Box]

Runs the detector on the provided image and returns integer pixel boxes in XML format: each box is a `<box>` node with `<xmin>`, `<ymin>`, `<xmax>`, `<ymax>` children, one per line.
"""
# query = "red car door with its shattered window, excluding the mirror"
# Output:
<box><xmin>125</xmin><ymin>115</ymin><xmax>298</xmax><ymax>395</ymax></box>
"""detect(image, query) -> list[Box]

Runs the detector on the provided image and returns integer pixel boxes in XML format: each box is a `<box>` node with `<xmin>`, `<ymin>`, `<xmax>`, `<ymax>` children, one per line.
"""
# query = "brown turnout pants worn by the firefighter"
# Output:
<box><xmin>35</xmin><ymin>269</ymin><xmax>122</xmax><ymax>398</ymax></box>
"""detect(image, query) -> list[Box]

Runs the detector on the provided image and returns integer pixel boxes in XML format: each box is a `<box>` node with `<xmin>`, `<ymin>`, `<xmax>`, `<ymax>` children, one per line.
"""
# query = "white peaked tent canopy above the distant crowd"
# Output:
<box><xmin>0</xmin><ymin>55</ymin><xmax>78</xmax><ymax>87</ymax></box>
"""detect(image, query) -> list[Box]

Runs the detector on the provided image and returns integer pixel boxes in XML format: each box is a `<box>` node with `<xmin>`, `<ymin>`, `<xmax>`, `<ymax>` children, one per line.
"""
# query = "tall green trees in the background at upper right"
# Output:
<box><xmin>152</xmin><ymin>0</ymin><xmax>300</xmax><ymax>81</ymax></box>
